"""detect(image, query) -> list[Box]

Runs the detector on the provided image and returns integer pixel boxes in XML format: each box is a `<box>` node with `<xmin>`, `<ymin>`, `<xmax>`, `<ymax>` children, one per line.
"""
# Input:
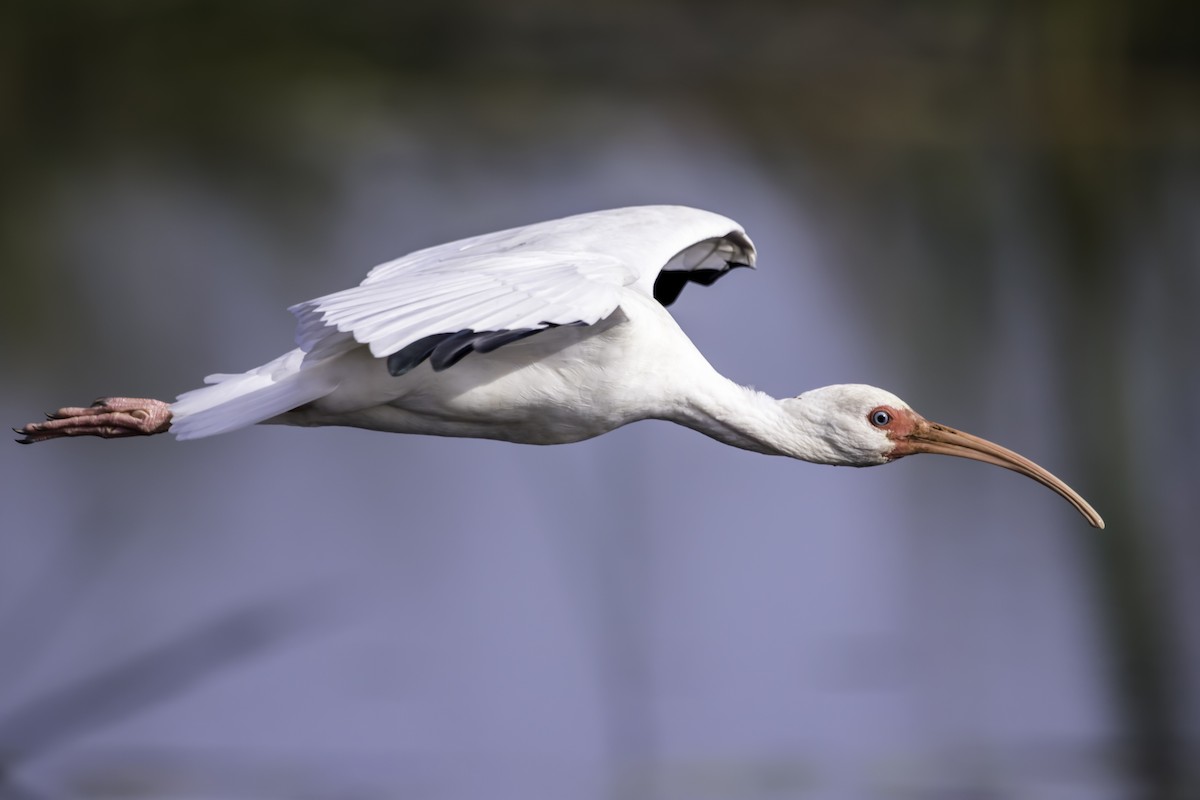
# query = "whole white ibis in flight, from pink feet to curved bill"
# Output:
<box><xmin>17</xmin><ymin>206</ymin><xmax>1104</xmax><ymax>528</ymax></box>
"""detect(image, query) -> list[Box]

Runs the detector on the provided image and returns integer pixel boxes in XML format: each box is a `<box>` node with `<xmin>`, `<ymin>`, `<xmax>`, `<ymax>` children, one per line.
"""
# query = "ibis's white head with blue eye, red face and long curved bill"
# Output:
<box><xmin>793</xmin><ymin>384</ymin><xmax>1104</xmax><ymax>528</ymax></box>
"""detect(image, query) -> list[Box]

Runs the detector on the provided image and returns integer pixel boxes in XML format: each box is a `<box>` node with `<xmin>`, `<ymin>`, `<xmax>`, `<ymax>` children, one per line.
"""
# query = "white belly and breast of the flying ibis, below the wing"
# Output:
<box><xmin>298</xmin><ymin>303</ymin><xmax>690</xmax><ymax>445</ymax></box>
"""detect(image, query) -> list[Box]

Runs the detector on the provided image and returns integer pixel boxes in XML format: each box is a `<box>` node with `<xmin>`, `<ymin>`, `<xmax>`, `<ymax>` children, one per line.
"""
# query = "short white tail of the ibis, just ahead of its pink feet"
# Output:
<box><xmin>170</xmin><ymin>350</ymin><xmax>337</xmax><ymax>439</ymax></box>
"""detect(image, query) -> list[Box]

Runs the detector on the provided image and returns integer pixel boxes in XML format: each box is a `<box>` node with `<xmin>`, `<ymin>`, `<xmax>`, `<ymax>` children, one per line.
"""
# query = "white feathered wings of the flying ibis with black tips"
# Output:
<box><xmin>290</xmin><ymin>206</ymin><xmax>754</xmax><ymax>375</ymax></box>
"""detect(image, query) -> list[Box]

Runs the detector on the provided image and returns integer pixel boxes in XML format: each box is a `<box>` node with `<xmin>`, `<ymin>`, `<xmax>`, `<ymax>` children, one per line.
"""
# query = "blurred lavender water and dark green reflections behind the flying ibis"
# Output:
<box><xmin>0</xmin><ymin>0</ymin><xmax>1200</xmax><ymax>800</ymax></box>
